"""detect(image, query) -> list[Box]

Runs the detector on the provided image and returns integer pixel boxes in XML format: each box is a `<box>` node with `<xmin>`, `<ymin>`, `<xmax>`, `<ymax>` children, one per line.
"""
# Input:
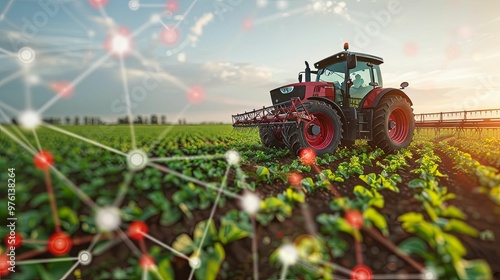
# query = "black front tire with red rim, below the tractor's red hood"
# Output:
<box><xmin>283</xmin><ymin>100</ymin><xmax>343</xmax><ymax>156</ymax></box>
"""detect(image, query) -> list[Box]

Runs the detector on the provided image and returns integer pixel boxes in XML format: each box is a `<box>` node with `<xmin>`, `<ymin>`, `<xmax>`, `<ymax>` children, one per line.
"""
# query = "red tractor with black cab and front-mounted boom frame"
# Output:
<box><xmin>232</xmin><ymin>43</ymin><xmax>415</xmax><ymax>158</ymax></box>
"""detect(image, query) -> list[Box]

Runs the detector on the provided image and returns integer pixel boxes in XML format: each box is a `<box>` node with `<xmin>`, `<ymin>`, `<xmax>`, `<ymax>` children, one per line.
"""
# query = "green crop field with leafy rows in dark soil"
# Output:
<box><xmin>0</xmin><ymin>125</ymin><xmax>500</xmax><ymax>279</ymax></box>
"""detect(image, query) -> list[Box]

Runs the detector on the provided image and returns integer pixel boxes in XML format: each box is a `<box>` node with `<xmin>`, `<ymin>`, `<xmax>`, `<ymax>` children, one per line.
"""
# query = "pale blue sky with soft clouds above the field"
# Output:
<box><xmin>0</xmin><ymin>0</ymin><xmax>500</xmax><ymax>123</ymax></box>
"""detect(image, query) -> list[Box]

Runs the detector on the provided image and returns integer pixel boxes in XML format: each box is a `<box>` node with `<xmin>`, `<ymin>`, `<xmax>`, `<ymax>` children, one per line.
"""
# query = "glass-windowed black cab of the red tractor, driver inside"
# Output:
<box><xmin>314</xmin><ymin>46</ymin><xmax>384</xmax><ymax>108</ymax></box>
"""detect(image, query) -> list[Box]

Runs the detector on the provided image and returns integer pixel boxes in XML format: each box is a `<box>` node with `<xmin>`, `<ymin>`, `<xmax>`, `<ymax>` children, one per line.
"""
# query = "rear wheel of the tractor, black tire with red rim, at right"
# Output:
<box><xmin>370</xmin><ymin>95</ymin><xmax>415</xmax><ymax>153</ymax></box>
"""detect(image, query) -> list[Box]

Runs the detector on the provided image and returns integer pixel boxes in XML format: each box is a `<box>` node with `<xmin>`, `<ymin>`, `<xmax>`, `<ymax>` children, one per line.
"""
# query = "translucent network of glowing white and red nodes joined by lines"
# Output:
<box><xmin>0</xmin><ymin>0</ymin><xmax>442</xmax><ymax>279</ymax></box>
